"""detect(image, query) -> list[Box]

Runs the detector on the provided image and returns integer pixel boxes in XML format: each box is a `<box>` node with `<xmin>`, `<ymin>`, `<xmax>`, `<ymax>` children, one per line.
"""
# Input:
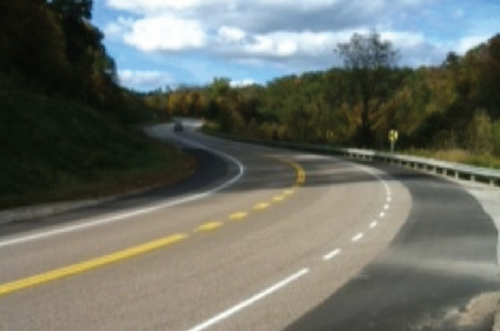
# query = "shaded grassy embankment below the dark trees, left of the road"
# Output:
<box><xmin>0</xmin><ymin>83</ymin><xmax>195</xmax><ymax>208</ymax></box>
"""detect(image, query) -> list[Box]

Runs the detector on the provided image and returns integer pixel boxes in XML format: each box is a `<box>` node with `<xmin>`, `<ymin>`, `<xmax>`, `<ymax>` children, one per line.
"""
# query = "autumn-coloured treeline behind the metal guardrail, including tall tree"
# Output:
<box><xmin>146</xmin><ymin>34</ymin><xmax>500</xmax><ymax>156</ymax></box>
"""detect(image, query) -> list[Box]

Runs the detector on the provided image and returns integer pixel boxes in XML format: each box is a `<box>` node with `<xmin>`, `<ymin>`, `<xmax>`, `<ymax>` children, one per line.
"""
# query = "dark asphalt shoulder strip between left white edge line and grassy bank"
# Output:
<box><xmin>0</xmin><ymin>148</ymin><xmax>230</xmax><ymax>238</ymax></box>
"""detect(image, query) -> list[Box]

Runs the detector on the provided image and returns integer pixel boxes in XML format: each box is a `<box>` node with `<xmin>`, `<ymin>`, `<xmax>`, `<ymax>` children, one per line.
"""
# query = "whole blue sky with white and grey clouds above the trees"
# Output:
<box><xmin>92</xmin><ymin>0</ymin><xmax>500</xmax><ymax>91</ymax></box>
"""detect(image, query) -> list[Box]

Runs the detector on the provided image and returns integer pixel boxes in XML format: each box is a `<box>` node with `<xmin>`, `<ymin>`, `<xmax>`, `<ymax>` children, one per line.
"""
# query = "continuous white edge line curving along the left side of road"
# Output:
<box><xmin>0</xmin><ymin>139</ymin><xmax>245</xmax><ymax>248</ymax></box>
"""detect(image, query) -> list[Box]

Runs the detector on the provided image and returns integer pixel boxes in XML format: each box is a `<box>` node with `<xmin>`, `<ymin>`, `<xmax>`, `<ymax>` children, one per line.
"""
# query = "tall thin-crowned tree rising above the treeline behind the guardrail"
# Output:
<box><xmin>335</xmin><ymin>31</ymin><xmax>399</xmax><ymax>147</ymax></box>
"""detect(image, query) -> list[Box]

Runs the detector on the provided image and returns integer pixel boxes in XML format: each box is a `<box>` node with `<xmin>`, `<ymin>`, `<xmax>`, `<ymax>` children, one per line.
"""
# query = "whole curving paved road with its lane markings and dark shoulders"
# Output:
<box><xmin>0</xmin><ymin>125</ymin><xmax>499</xmax><ymax>331</ymax></box>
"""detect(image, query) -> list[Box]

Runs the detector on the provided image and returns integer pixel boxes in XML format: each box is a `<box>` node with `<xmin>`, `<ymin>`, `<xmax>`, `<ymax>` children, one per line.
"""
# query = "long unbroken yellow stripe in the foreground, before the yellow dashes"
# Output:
<box><xmin>0</xmin><ymin>234</ymin><xmax>188</xmax><ymax>296</ymax></box>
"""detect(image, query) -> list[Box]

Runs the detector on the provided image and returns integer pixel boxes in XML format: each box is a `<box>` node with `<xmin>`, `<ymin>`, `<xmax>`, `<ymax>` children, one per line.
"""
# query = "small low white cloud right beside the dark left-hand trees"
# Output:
<box><xmin>118</xmin><ymin>70</ymin><xmax>173</xmax><ymax>89</ymax></box>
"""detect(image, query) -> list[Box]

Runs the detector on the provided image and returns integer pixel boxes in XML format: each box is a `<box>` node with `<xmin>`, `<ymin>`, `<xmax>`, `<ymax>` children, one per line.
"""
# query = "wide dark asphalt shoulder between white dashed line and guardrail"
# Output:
<box><xmin>286</xmin><ymin>166</ymin><xmax>500</xmax><ymax>331</ymax></box>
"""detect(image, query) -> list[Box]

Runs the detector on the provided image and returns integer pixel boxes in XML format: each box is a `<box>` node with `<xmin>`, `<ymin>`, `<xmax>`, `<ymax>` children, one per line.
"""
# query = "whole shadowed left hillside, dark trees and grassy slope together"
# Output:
<box><xmin>0</xmin><ymin>0</ymin><xmax>195</xmax><ymax>208</ymax></box>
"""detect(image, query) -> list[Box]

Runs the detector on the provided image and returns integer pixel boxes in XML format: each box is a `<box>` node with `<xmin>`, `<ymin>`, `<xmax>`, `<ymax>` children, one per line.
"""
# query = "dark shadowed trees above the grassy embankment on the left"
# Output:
<box><xmin>0</xmin><ymin>0</ymin><xmax>159</xmax><ymax>122</ymax></box>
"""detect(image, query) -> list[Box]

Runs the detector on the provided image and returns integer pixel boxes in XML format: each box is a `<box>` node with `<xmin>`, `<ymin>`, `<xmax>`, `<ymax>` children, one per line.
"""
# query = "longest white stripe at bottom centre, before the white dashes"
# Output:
<box><xmin>188</xmin><ymin>269</ymin><xmax>310</xmax><ymax>331</ymax></box>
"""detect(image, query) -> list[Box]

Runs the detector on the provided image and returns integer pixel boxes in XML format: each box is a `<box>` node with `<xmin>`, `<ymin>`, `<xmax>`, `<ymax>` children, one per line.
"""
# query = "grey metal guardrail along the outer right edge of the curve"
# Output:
<box><xmin>211</xmin><ymin>135</ymin><xmax>500</xmax><ymax>186</ymax></box>
